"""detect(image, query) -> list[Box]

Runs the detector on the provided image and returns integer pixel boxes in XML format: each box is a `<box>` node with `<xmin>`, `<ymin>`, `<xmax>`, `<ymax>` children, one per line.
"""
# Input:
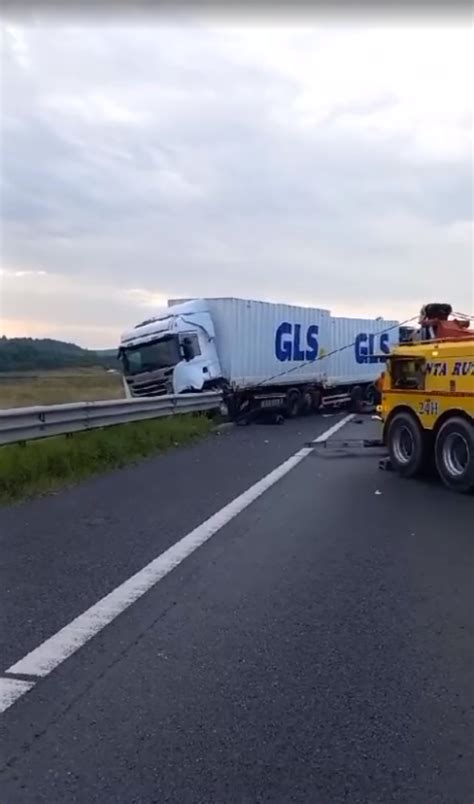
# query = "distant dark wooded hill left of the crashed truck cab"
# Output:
<box><xmin>0</xmin><ymin>336</ymin><xmax>118</xmax><ymax>372</ymax></box>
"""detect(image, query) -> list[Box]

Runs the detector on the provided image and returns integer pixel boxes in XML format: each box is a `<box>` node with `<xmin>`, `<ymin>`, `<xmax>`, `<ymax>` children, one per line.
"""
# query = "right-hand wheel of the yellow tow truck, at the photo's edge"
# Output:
<box><xmin>435</xmin><ymin>417</ymin><xmax>474</xmax><ymax>493</ymax></box>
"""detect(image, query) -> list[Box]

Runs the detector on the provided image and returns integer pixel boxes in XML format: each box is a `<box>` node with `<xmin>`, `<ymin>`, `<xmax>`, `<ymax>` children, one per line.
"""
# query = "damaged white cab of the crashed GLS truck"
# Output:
<box><xmin>119</xmin><ymin>299</ymin><xmax>222</xmax><ymax>397</ymax></box>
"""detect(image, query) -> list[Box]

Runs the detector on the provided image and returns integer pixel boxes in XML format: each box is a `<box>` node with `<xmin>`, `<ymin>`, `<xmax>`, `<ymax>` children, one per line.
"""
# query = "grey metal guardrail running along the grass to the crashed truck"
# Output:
<box><xmin>0</xmin><ymin>391</ymin><xmax>222</xmax><ymax>445</ymax></box>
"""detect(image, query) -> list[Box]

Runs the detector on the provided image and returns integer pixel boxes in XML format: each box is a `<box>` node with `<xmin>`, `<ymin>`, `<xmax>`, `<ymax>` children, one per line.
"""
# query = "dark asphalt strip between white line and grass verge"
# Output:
<box><xmin>0</xmin><ymin>416</ymin><xmax>341</xmax><ymax>670</ymax></box>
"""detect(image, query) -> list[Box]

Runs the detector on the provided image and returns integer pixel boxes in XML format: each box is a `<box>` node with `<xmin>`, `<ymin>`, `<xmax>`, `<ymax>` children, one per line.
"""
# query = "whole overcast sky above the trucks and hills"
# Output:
<box><xmin>0</xmin><ymin>14</ymin><xmax>474</xmax><ymax>347</ymax></box>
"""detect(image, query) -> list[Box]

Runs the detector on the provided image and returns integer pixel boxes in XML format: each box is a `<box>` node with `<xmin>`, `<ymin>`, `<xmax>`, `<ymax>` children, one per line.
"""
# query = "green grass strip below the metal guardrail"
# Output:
<box><xmin>0</xmin><ymin>415</ymin><xmax>212</xmax><ymax>502</ymax></box>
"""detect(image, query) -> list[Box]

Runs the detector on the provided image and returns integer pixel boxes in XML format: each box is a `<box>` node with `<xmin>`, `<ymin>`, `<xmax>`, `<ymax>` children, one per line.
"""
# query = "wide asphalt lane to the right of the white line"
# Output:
<box><xmin>0</xmin><ymin>420</ymin><xmax>474</xmax><ymax>804</ymax></box>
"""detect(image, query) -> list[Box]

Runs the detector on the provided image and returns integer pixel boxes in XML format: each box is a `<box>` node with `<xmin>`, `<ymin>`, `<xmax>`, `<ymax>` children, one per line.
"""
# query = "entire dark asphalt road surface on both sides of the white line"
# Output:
<box><xmin>0</xmin><ymin>417</ymin><xmax>474</xmax><ymax>804</ymax></box>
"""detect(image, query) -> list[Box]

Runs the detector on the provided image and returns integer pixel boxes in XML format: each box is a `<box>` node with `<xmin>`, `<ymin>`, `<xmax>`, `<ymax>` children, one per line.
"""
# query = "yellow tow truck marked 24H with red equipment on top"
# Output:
<box><xmin>379</xmin><ymin>304</ymin><xmax>474</xmax><ymax>493</ymax></box>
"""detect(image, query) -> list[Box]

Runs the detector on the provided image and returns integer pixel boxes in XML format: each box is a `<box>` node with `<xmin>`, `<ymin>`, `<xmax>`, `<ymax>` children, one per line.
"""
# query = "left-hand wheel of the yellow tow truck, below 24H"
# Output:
<box><xmin>386</xmin><ymin>411</ymin><xmax>426</xmax><ymax>477</ymax></box>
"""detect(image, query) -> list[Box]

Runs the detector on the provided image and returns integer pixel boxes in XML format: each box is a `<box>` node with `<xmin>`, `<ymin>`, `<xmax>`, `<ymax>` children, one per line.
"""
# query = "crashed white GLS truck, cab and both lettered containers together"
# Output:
<box><xmin>119</xmin><ymin>298</ymin><xmax>396</xmax><ymax>417</ymax></box>
